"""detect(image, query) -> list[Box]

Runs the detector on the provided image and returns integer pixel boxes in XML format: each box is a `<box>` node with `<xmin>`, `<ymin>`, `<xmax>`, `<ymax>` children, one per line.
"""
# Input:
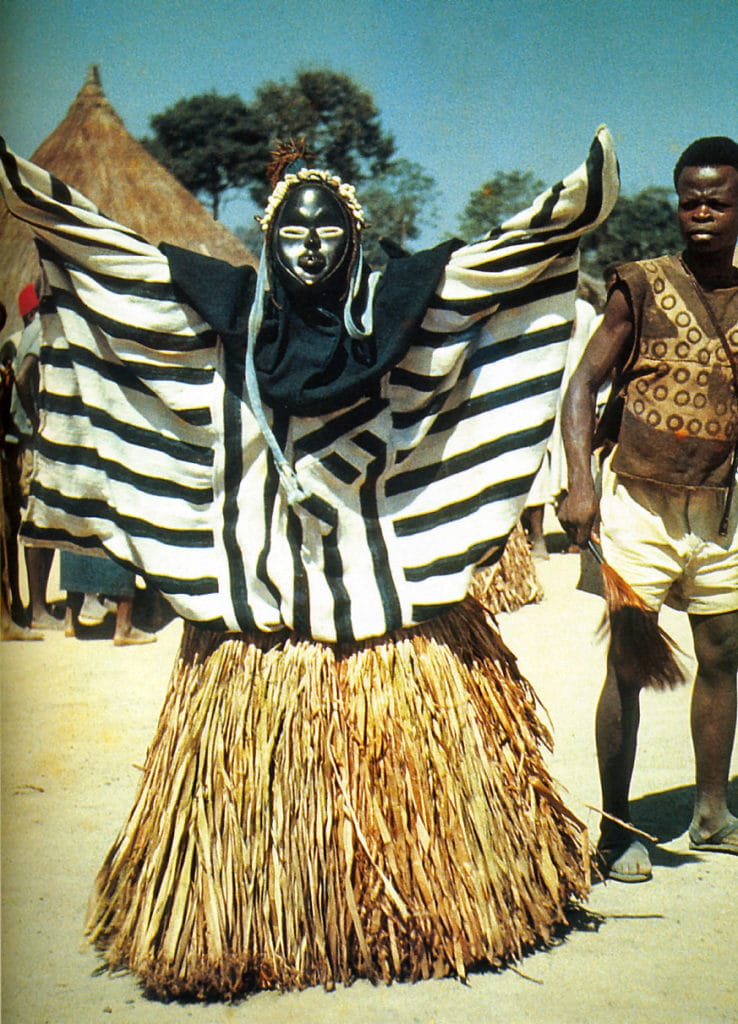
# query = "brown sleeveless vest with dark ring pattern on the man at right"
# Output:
<box><xmin>612</xmin><ymin>256</ymin><xmax>738</xmax><ymax>487</ymax></box>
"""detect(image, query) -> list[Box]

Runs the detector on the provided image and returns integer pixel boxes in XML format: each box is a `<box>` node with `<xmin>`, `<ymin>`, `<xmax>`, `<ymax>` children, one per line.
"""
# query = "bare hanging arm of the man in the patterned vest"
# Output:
<box><xmin>558</xmin><ymin>288</ymin><xmax>634</xmax><ymax>547</ymax></box>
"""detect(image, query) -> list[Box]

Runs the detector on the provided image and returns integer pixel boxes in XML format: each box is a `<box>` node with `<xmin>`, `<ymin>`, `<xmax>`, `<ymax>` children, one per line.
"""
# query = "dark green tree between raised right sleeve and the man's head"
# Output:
<box><xmin>581</xmin><ymin>186</ymin><xmax>682</xmax><ymax>275</ymax></box>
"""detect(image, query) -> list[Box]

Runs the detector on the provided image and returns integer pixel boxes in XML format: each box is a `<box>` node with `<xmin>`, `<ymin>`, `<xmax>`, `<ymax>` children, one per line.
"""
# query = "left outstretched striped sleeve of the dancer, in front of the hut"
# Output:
<box><xmin>0</xmin><ymin>143</ymin><xmax>234</xmax><ymax>623</ymax></box>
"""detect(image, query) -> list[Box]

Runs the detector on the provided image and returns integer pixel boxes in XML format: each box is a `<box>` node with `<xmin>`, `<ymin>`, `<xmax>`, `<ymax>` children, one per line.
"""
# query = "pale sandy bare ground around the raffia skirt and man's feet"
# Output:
<box><xmin>0</xmin><ymin>538</ymin><xmax>738</xmax><ymax>1024</ymax></box>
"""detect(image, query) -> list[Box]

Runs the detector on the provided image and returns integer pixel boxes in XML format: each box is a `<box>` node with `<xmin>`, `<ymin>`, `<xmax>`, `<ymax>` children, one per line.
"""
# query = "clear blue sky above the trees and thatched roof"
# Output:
<box><xmin>0</xmin><ymin>0</ymin><xmax>738</xmax><ymax>241</ymax></box>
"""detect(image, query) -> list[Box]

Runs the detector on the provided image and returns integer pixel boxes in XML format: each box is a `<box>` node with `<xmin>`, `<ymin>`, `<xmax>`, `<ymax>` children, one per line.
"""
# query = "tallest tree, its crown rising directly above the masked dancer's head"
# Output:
<box><xmin>251</xmin><ymin>70</ymin><xmax>395</xmax><ymax>205</ymax></box>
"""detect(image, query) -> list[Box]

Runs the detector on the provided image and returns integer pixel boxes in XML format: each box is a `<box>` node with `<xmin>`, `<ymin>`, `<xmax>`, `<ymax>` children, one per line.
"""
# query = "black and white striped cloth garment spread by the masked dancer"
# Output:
<box><xmin>2</xmin><ymin>127</ymin><xmax>618</xmax><ymax>642</ymax></box>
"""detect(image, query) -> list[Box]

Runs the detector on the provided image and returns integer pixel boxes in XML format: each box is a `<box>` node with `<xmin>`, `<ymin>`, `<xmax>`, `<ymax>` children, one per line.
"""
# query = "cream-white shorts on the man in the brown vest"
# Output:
<box><xmin>600</xmin><ymin>459</ymin><xmax>738</xmax><ymax>615</ymax></box>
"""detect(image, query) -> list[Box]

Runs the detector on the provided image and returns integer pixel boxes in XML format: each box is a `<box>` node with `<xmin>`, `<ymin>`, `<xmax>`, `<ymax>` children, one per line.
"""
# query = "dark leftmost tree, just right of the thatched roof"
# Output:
<box><xmin>141</xmin><ymin>92</ymin><xmax>268</xmax><ymax>219</ymax></box>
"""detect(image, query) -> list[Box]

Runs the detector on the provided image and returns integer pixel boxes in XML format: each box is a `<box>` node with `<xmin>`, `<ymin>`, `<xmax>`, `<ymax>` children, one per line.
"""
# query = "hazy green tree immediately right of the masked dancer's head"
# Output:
<box><xmin>359</xmin><ymin>159</ymin><xmax>438</xmax><ymax>266</ymax></box>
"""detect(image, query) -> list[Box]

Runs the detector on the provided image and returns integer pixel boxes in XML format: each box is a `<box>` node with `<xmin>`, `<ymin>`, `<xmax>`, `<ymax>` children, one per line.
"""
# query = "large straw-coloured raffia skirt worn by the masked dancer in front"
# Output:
<box><xmin>87</xmin><ymin>598</ymin><xmax>590</xmax><ymax>997</ymax></box>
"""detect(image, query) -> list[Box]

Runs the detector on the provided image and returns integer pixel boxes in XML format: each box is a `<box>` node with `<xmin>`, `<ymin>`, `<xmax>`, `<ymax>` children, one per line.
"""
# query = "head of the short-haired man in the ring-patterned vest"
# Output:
<box><xmin>674</xmin><ymin>135</ymin><xmax>738</xmax><ymax>255</ymax></box>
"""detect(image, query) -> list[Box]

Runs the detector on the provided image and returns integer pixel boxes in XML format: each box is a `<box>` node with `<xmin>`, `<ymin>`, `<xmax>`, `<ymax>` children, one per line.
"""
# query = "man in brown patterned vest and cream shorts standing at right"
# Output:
<box><xmin>559</xmin><ymin>136</ymin><xmax>738</xmax><ymax>882</ymax></box>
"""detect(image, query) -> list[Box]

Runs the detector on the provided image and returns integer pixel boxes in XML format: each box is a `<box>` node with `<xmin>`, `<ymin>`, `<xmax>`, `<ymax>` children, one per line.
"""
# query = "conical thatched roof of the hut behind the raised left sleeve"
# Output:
<box><xmin>0</xmin><ymin>66</ymin><xmax>257</xmax><ymax>331</ymax></box>
